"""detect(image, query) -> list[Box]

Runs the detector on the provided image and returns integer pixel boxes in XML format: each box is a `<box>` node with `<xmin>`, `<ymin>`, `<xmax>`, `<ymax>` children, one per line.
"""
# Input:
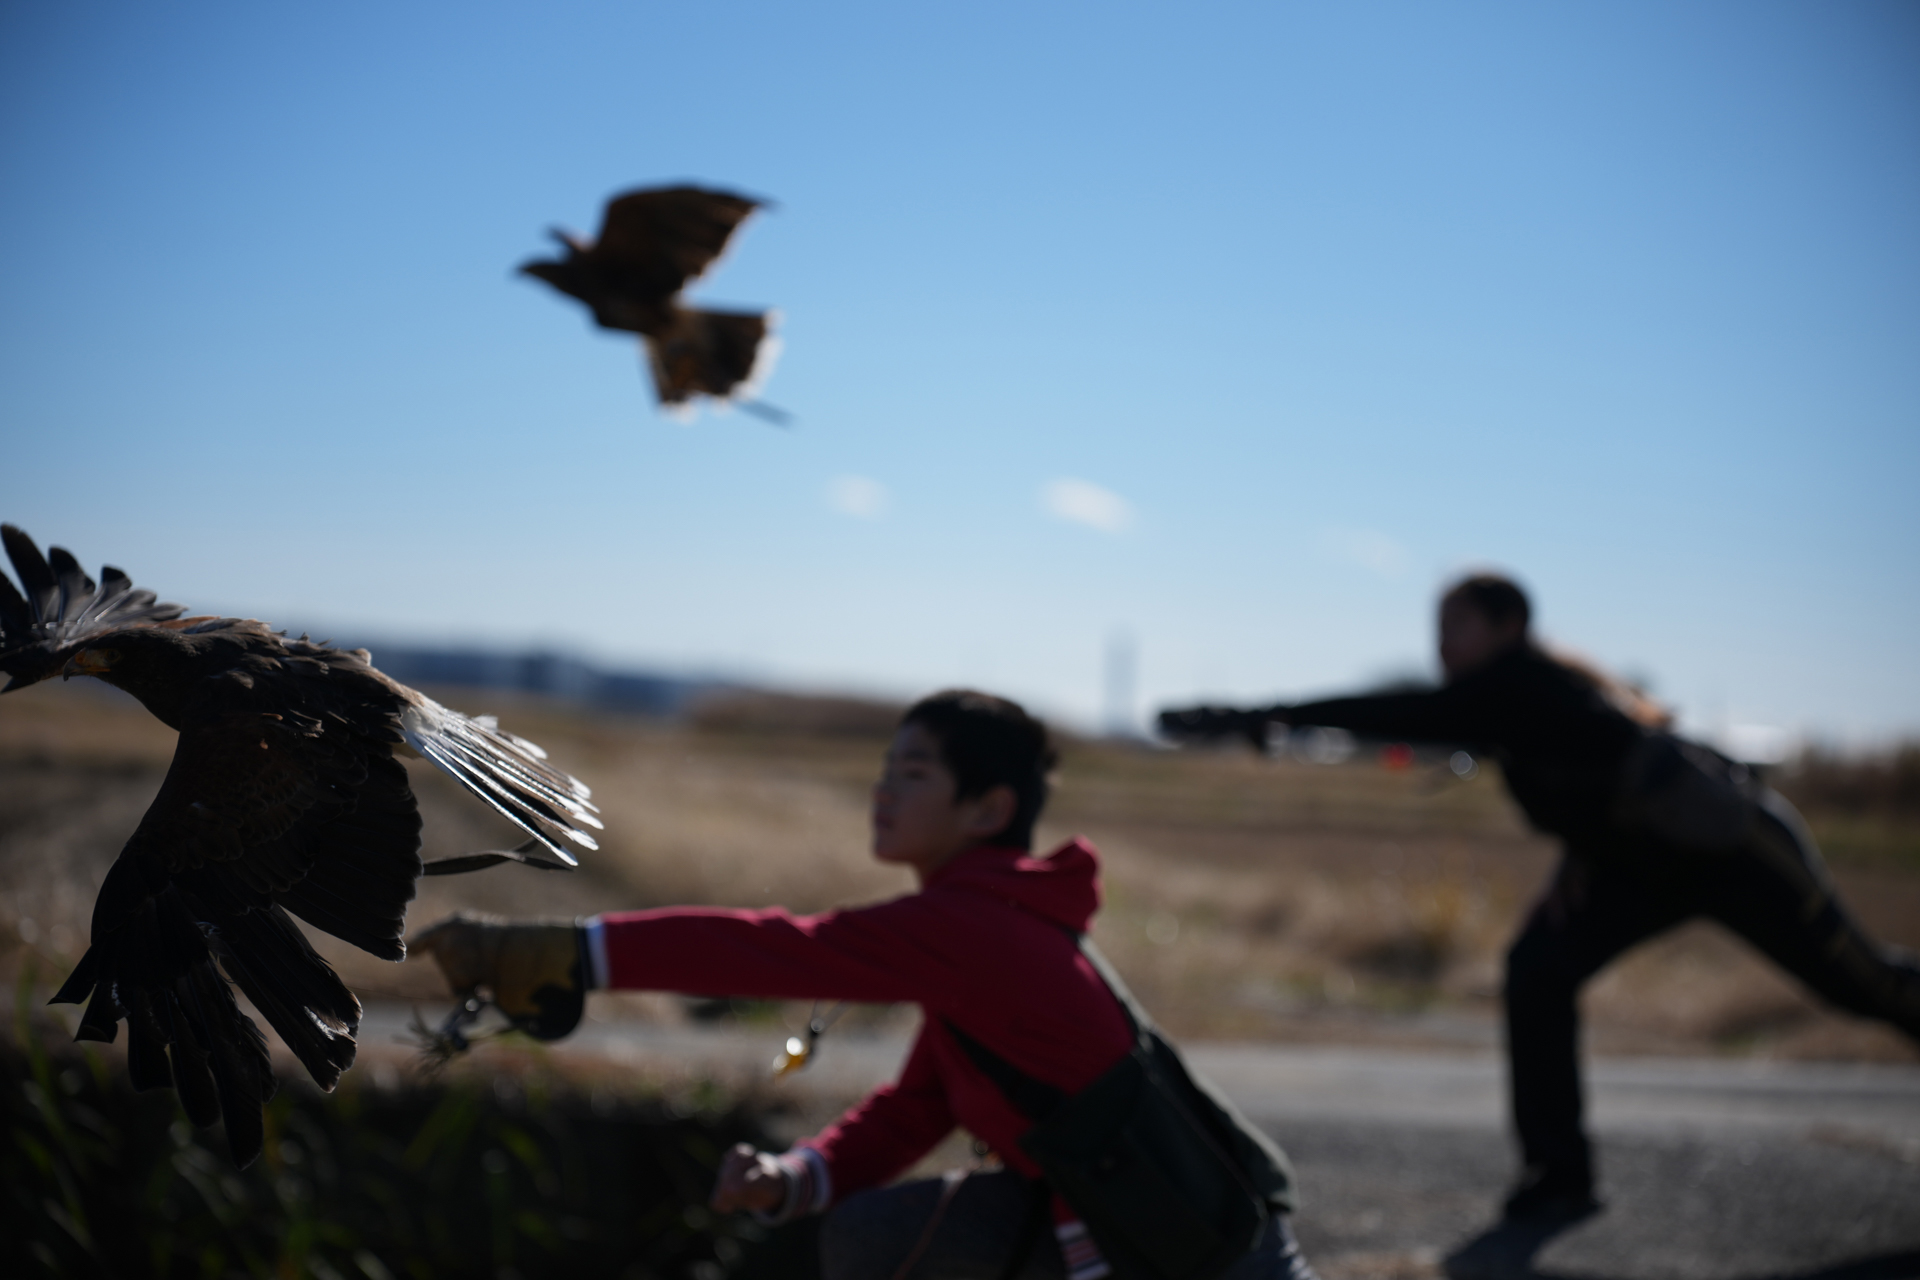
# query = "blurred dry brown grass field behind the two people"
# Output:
<box><xmin>0</xmin><ymin>681</ymin><xmax>1920</xmax><ymax>1061</ymax></box>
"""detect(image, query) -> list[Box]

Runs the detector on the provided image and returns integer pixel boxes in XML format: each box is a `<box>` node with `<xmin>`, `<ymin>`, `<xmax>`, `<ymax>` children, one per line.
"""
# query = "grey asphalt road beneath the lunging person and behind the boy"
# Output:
<box><xmin>361</xmin><ymin>1007</ymin><xmax>1920</xmax><ymax>1280</ymax></box>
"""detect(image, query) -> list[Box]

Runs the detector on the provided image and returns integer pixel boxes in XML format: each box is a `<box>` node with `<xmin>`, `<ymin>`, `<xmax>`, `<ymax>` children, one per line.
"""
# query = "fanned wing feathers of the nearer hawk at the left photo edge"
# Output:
<box><xmin>0</xmin><ymin>524</ymin><xmax>186</xmax><ymax>693</ymax></box>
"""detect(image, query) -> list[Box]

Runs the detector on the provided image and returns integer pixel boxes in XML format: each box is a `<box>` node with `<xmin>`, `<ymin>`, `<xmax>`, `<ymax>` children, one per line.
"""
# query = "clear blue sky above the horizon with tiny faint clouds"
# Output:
<box><xmin>0</xmin><ymin>0</ymin><xmax>1920</xmax><ymax>741</ymax></box>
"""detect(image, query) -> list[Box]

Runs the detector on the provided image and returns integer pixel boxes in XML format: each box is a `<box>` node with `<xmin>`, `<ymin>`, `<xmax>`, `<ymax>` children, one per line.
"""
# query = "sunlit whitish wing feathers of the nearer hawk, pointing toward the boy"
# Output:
<box><xmin>394</xmin><ymin>683</ymin><xmax>603</xmax><ymax>867</ymax></box>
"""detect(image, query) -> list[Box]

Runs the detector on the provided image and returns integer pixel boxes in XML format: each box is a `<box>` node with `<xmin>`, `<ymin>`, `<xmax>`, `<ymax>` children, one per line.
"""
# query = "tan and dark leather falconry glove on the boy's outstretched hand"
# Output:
<box><xmin>407</xmin><ymin>913</ymin><xmax>593</xmax><ymax>1040</ymax></box>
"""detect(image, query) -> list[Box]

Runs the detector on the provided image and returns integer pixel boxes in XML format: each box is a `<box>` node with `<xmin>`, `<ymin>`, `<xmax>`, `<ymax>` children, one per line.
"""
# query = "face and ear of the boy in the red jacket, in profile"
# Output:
<box><xmin>874</xmin><ymin>723</ymin><xmax>1016</xmax><ymax>875</ymax></box>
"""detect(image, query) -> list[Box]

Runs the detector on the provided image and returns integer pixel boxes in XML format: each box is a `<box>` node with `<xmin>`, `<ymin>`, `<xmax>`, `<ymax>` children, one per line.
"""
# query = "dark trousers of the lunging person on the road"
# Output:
<box><xmin>1505</xmin><ymin>794</ymin><xmax>1920</xmax><ymax>1186</ymax></box>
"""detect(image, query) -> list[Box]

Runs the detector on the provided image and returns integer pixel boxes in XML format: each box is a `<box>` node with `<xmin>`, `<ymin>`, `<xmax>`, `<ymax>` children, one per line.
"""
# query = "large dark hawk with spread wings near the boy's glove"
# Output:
<box><xmin>0</xmin><ymin>524</ymin><xmax>601</xmax><ymax>1165</ymax></box>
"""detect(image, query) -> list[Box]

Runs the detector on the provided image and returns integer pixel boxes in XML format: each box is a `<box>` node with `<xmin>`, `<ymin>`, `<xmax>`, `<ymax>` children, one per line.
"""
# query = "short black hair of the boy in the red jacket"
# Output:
<box><xmin>900</xmin><ymin>689</ymin><xmax>1058</xmax><ymax>848</ymax></box>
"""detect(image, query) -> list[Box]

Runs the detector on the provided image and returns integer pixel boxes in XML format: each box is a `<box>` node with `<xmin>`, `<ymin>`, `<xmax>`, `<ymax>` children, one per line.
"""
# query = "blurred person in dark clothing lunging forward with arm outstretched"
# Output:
<box><xmin>1160</xmin><ymin>576</ymin><xmax>1920</xmax><ymax>1221</ymax></box>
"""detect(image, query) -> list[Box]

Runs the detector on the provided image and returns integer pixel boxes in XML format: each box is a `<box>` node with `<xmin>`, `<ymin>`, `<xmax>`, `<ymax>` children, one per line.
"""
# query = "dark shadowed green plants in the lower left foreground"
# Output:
<box><xmin>0</xmin><ymin>975</ymin><xmax>794</xmax><ymax>1280</ymax></box>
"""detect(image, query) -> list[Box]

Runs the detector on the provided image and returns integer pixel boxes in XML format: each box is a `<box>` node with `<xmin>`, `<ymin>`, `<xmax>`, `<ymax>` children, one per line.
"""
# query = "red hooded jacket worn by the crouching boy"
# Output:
<box><xmin>599</xmin><ymin>841</ymin><xmax>1131</xmax><ymax>1199</ymax></box>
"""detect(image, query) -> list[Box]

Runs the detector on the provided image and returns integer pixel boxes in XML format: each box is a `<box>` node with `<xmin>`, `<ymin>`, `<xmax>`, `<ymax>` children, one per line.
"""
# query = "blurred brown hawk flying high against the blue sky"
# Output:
<box><xmin>520</xmin><ymin>186</ymin><xmax>783</xmax><ymax>418</ymax></box>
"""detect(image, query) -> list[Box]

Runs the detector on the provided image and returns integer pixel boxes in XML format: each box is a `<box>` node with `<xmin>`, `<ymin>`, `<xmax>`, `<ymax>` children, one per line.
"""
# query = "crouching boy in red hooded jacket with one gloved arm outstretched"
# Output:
<box><xmin>415</xmin><ymin>691</ymin><xmax>1311</xmax><ymax>1280</ymax></box>
